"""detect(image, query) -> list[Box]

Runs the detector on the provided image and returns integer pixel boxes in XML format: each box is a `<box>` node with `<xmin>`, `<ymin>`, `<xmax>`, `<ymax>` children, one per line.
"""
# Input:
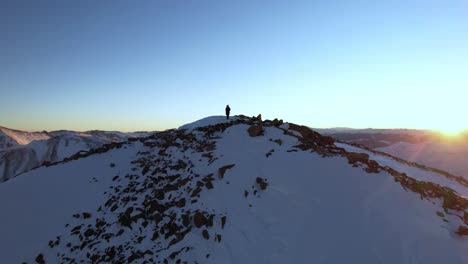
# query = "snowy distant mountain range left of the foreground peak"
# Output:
<box><xmin>0</xmin><ymin>127</ymin><xmax>151</xmax><ymax>182</ymax></box>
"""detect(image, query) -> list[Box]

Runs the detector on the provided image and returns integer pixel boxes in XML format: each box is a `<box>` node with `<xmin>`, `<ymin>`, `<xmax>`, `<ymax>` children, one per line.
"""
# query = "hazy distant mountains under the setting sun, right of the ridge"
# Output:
<box><xmin>317</xmin><ymin>128</ymin><xmax>468</xmax><ymax>179</ymax></box>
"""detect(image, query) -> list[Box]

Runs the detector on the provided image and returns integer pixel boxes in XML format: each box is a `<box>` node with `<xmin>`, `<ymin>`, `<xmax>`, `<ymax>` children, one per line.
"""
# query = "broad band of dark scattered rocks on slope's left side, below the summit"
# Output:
<box><xmin>51</xmin><ymin>127</ymin><xmax>230</xmax><ymax>263</ymax></box>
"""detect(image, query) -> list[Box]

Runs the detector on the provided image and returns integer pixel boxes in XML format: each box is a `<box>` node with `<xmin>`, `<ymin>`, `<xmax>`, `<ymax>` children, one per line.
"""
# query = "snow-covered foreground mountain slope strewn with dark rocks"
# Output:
<box><xmin>0</xmin><ymin>117</ymin><xmax>468</xmax><ymax>263</ymax></box>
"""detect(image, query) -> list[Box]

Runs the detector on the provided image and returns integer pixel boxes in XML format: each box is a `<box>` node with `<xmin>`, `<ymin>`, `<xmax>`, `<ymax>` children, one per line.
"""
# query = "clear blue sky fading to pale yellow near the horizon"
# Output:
<box><xmin>0</xmin><ymin>0</ymin><xmax>468</xmax><ymax>131</ymax></box>
